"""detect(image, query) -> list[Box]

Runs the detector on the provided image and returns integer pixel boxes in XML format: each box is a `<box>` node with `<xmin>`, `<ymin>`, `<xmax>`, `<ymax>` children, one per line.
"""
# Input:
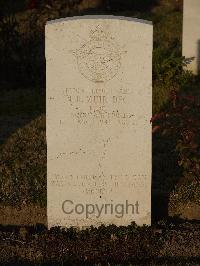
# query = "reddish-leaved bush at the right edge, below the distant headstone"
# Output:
<box><xmin>173</xmin><ymin>97</ymin><xmax>200</xmax><ymax>182</ymax></box>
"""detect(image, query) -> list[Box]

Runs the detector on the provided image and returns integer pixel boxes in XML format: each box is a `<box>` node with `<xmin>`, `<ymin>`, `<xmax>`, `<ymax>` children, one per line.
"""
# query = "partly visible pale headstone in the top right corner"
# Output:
<box><xmin>183</xmin><ymin>0</ymin><xmax>200</xmax><ymax>74</ymax></box>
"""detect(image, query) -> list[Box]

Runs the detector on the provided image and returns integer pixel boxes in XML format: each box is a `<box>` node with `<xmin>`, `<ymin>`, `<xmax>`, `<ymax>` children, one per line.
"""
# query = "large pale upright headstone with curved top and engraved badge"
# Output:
<box><xmin>46</xmin><ymin>16</ymin><xmax>153</xmax><ymax>228</ymax></box>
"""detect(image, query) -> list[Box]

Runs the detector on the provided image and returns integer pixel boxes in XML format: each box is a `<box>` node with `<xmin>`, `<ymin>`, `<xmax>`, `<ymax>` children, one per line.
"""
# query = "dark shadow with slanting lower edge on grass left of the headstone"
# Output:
<box><xmin>0</xmin><ymin>89</ymin><xmax>46</xmax><ymax>145</ymax></box>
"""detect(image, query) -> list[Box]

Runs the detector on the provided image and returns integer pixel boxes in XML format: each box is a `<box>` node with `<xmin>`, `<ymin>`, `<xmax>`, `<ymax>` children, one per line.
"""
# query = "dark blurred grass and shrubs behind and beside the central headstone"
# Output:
<box><xmin>0</xmin><ymin>0</ymin><xmax>200</xmax><ymax>218</ymax></box>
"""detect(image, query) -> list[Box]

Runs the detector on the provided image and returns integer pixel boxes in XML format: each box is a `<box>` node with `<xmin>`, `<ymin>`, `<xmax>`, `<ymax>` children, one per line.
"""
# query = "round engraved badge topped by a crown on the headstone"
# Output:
<box><xmin>74</xmin><ymin>26</ymin><xmax>126</xmax><ymax>83</ymax></box>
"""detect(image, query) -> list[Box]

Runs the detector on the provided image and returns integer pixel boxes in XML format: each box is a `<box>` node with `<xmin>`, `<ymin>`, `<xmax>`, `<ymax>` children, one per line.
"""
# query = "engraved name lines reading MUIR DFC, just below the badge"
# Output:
<box><xmin>64</xmin><ymin>88</ymin><xmax>135</xmax><ymax>126</ymax></box>
